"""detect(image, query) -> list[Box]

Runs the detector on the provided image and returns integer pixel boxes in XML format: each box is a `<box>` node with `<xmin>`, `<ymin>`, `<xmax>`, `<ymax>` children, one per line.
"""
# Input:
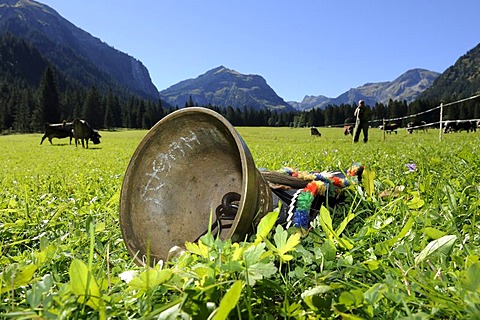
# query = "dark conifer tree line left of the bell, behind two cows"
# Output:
<box><xmin>0</xmin><ymin>67</ymin><xmax>172</xmax><ymax>133</ymax></box>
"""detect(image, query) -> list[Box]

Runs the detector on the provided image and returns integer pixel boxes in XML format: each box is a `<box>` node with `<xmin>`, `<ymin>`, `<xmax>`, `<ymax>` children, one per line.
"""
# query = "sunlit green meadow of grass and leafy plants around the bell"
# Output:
<box><xmin>0</xmin><ymin>127</ymin><xmax>480</xmax><ymax>319</ymax></box>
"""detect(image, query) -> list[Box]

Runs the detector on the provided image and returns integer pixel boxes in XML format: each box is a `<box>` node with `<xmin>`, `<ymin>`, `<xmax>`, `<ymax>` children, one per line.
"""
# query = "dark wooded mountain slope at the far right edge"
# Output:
<box><xmin>419</xmin><ymin>44</ymin><xmax>480</xmax><ymax>102</ymax></box>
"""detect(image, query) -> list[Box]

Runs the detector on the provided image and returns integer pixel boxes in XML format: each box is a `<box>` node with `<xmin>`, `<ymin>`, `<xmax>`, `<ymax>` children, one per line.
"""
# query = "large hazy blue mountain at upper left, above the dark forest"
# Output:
<box><xmin>0</xmin><ymin>0</ymin><xmax>159</xmax><ymax>98</ymax></box>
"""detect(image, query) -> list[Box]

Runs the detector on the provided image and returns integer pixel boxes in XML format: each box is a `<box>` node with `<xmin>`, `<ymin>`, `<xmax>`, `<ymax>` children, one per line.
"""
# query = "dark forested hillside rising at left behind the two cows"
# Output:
<box><xmin>0</xmin><ymin>34</ymin><xmax>168</xmax><ymax>133</ymax></box>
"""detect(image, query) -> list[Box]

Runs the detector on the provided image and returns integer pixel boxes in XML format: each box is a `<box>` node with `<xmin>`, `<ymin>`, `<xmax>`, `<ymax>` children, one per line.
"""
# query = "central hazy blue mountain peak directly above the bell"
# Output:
<box><xmin>160</xmin><ymin>66</ymin><xmax>293</xmax><ymax>111</ymax></box>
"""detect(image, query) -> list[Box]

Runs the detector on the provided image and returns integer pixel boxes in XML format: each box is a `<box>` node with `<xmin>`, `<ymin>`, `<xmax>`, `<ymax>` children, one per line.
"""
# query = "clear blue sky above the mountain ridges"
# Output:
<box><xmin>40</xmin><ymin>0</ymin><xmax>480</xmax><ymax>101</ymax></box>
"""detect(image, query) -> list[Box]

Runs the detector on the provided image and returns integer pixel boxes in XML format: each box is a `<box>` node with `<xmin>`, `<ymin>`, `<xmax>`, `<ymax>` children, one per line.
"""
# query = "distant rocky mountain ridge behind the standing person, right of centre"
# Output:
<box><xmin>289</xmin><ymin>69</ymin><xmax>440</xmax><ymax>110</ymax></box>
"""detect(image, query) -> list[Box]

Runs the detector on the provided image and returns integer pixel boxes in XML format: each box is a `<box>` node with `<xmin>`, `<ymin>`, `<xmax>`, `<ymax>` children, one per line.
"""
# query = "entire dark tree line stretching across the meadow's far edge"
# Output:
<box><xmin>0</xmin><ymin>67</ymin><xmax>480</xmax><ymax>133</ymax></box>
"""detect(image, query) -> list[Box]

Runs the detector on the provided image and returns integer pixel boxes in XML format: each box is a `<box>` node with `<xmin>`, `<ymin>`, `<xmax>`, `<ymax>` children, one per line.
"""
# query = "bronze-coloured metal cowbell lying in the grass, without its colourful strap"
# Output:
<box><xmin>120</xmin><ymin>107</ymin><xmax>272</xmax><ymax>265</ymax></box>
